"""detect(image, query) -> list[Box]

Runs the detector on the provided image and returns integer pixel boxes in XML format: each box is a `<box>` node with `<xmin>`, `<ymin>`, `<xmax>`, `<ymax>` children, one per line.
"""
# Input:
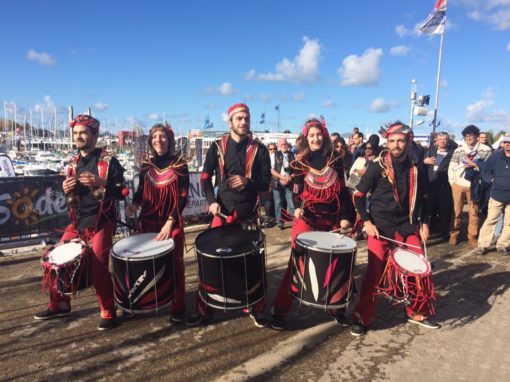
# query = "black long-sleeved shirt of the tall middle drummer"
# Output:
<box><xmin>201</xmin><ymin>137</ymin><xmax>271</xmax><ymax>220</ymax></box>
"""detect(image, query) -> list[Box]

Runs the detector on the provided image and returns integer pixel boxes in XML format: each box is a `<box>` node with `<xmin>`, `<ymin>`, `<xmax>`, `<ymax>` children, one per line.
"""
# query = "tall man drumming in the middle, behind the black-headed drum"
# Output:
<box><xmin>186</xmin><ymin>103</ymin><xmax>271</xmax><ymax>327</ymax></box>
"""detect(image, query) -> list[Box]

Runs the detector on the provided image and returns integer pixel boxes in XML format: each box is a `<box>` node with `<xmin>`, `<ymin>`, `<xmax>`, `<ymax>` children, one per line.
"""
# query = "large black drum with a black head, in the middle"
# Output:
<box><xmin>195</xmin><ymin>225</ymin><xmax>266</xmax><ymax>311</ymax></box>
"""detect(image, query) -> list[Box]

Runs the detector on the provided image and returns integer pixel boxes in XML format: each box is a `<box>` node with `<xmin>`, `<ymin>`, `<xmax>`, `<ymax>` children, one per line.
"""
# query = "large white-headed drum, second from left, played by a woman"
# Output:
<box><xmin>112</xmin><ymin>233</ymin><xmax>175</xmax><ymax>313</ymax></box>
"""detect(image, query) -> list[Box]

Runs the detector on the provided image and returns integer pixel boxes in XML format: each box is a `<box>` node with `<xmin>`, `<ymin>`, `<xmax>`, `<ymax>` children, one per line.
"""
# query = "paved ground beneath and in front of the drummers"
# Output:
<box><xmin>0</xmin><ymin>222</ymin><xmax>510</xmax><ymax>381</ymax></box>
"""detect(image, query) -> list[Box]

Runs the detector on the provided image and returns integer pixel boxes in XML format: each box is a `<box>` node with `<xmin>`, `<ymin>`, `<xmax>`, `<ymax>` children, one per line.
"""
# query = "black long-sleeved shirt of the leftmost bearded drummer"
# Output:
<box><xmin>73</xmin><ymin>148</ymin><xmax>124</xmax><ymax>232</ymax></box>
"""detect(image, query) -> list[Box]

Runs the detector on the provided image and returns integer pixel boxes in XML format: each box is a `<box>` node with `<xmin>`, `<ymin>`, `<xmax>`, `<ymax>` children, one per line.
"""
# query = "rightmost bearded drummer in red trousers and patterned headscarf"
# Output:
<box><xmin>351</xmin><ymin>121</ymin><xmax>440</xmax><ymax>337</ymax></box>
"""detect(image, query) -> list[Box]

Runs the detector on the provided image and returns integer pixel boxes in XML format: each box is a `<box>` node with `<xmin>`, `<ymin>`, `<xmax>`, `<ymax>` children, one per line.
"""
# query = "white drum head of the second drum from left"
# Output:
<box><xmin>112</xmin><ymin>233</ymin><xmax>175</xmax><ymax>260</ymax></box>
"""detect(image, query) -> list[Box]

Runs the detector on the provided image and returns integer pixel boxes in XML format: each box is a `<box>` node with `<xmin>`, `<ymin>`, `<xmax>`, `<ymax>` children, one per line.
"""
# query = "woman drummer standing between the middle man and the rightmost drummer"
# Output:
<box><xmin>271</xmin><ymin>117</ymin><xmax>354</xmax><ymax>330</ymax></box>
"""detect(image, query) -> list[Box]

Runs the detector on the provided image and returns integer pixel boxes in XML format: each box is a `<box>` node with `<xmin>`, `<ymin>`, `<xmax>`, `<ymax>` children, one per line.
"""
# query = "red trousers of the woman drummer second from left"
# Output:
<box><xmin>137</xmin><ymin>220</ymin><xmax>186</xmax><ymax>314</ymax></box>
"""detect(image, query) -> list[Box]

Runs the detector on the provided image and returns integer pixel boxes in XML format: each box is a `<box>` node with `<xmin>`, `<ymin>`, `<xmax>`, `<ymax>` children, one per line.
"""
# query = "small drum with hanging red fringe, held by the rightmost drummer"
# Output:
<box><xmin>378</xmin><ymin>248</ymin><xmax>435</xmax><ymax>311</ymax></box>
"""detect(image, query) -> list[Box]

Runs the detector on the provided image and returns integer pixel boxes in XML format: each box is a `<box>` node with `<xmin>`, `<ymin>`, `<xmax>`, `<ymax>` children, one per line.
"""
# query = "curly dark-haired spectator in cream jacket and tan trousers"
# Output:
<box><xmin>448</xmin><ymin>125</ymin><xmax>491</xmax><ymax>247</ymax></box>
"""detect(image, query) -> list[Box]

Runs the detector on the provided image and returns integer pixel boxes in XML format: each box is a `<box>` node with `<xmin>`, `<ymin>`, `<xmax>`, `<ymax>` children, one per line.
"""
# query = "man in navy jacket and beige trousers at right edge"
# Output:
<box><xmin>475</xmin><ymin>133</ymin><xmax>510</xmax><ymax>255</ymax></box>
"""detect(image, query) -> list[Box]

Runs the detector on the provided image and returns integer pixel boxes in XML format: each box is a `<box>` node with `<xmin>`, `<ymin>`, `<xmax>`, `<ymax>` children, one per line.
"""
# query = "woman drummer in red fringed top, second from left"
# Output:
<box><xmin>126</xmin><ymin>123</ymin><xmax>189</xmax><ymax>324</ymax></box>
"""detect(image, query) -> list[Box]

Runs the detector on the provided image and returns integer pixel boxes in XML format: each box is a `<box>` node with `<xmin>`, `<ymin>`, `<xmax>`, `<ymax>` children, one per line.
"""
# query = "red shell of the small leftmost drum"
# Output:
<box><xmin>41</xmin><ymin>242</ymin><xmax>91</xmax><ymax>296</ymax></box>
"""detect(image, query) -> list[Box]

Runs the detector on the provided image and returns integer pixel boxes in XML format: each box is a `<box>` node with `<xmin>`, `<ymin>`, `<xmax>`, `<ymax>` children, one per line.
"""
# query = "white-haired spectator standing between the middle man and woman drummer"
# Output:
<box><xmin>270</xmin><ymin>138</ymin><xmax>294</xmax><ymax>229</ymax></box>
